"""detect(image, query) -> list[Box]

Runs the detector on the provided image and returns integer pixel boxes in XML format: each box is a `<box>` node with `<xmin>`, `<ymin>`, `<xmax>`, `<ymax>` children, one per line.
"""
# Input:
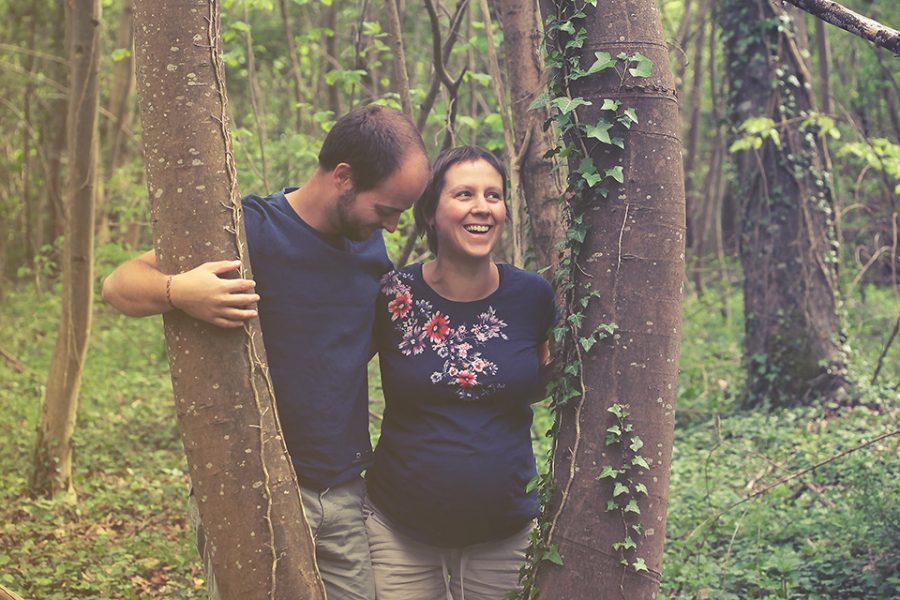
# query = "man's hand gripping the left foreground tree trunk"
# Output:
<box><xmin>169</xmin><ymin>260</ymin><xmax>259</xmax><ymax>327</ymax></box>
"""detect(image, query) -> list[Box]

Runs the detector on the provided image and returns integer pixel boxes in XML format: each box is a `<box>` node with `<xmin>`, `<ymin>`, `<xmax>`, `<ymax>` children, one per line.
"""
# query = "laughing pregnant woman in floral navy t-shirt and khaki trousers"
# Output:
<box><xmin>366</xmin><ymin>146</ymin><xmax>556</xmax><ymax>600</ymax></box>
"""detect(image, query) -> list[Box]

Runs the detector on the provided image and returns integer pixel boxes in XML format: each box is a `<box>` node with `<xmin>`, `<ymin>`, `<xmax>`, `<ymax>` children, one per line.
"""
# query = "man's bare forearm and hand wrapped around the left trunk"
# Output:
<box><xmin>103</xmin><ymin>250</ymin><xmax>259</xmax><ymax>327</ymax></box>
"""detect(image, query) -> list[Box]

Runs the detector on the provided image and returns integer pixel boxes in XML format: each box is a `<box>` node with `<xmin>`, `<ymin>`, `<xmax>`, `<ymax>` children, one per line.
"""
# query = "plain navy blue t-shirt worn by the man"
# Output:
<box><xmin>243</xmin><ymin>190</ymin><xmax>391</xmax><ymax>489</ymax></box>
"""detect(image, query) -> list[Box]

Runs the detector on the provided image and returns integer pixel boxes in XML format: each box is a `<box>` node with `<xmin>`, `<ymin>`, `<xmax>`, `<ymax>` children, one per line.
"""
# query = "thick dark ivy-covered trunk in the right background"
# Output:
<box><xmin>718</xmin><ymin>0</ymin><xmax>847</xmax><ymax>405</ymax></box>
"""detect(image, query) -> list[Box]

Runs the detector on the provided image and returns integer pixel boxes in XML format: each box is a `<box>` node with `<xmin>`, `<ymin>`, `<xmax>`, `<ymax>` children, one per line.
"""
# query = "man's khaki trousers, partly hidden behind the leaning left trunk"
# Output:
<box><xmin>188</xmin><ymin>477</ymin><xmax>375</xmax><ymax>600</ymax></box>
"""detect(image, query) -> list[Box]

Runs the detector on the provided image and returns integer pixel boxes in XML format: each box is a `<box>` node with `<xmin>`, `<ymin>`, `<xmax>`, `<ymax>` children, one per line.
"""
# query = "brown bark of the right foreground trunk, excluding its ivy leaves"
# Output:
<box><xmin>537</xmin><ymin>0</ymin><xmax>685</xmax><ymax>600</ymax></box>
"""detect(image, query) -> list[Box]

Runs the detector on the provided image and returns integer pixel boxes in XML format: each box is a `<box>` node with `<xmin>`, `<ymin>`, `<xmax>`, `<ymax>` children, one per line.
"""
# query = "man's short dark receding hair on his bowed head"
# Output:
<box><xmin>319</xmin><ymin>104</ymin><xmax>425</xmax><ymax>192</ymax></box>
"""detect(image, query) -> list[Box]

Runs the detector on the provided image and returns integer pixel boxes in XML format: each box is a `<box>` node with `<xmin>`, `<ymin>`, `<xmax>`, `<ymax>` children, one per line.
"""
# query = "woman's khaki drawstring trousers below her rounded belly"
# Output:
<box><xmin>363</xmin><ymin>499</ymin><xmax>534</xmax><ymax>600</ymax></box>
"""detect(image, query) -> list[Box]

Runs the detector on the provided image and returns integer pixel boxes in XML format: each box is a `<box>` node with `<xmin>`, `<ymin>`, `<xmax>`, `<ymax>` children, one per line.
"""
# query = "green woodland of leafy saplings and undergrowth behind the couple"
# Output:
<box><xmin>0</xmin><ymin>0</ymin><xmax>900</xmax><ymax>599</ymax></box>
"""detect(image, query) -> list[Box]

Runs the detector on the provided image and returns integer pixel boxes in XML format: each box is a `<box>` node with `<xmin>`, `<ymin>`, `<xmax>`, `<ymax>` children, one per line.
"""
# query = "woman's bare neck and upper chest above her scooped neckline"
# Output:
<box><xmin>422</xmin><ymin>254</ymin><xmax>500</xmax><ymax>302</ymax></box>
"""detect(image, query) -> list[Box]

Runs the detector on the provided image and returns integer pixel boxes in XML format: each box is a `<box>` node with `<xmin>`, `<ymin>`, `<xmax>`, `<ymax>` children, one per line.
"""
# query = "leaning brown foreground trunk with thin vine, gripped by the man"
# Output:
<box><xmin>134</xmin><ymin>0</ymin><xmax>325</xmax><ymax>600</ymax></box>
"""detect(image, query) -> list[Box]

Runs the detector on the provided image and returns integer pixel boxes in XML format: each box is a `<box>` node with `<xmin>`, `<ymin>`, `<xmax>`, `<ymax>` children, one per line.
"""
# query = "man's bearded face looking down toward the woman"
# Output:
<box><xmin>337</xmin><ymin>151</ymin><xmax>429</xmax><ymax>241</ymax></box>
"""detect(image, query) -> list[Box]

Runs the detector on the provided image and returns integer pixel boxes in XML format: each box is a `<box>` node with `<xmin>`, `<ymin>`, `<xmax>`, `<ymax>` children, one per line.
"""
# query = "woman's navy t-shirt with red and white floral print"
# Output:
<box><xmin>366</xmin><ymin>264</ymin><xmax>556</xmax><ymax>547</ymax></box>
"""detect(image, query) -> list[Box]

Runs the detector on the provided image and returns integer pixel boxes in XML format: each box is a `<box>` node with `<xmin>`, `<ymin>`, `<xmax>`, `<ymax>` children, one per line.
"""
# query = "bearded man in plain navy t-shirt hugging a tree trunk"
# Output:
<box><xmin>103</xmin><ymin>105</ymin><xmax>429</xmax><ymax>600</ymax></box>
